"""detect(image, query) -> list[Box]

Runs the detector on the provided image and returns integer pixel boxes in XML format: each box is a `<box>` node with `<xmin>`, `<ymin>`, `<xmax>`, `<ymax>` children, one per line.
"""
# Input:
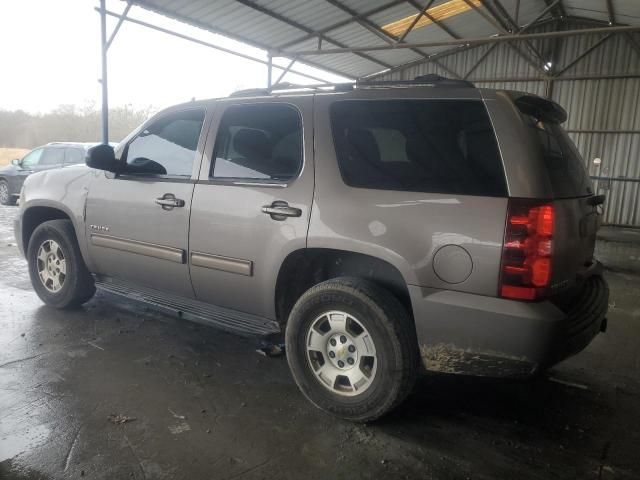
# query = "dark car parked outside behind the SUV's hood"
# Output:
<box><xmin>0</xmin><ymin>142</ymin><xmax>95</xmax><ymax>205</ymax></box>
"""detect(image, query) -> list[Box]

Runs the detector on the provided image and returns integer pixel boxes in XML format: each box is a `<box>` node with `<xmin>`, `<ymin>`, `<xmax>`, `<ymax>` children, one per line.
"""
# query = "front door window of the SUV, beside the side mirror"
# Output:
<box><xmin>124</xmin><ymin>109</ymin><xmax>204</xmax><ymax>177</ymax></box>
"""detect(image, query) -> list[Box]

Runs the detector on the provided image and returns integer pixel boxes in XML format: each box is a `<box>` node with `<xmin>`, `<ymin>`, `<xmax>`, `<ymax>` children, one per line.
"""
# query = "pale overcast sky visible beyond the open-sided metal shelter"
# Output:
<box><xmin>0</xmin><ymin>0</ymin><xmax>350</xmax><ymax>113</ymax></box>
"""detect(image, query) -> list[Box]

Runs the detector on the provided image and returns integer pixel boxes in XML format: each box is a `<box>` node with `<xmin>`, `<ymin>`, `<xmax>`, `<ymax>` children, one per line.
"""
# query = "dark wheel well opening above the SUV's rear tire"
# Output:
<box><xmin>274</xmin><ymin>248</ymin><xmax>413</xmax><ymax>325</ymax></box>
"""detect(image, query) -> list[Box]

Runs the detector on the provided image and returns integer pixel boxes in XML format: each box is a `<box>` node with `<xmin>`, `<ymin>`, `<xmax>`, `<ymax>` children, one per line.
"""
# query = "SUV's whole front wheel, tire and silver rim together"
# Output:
<box><xmin>27</xmin><ymin>220</ymin><xmax>96</xmax><ymax>308</ymax></box>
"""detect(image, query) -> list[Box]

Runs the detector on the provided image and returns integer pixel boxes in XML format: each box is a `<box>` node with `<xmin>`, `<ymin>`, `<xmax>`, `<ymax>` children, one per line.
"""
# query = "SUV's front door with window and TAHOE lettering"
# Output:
<box><xmin>85</xmin><ymin>108</ymin><xmax>205</xmax><ymax>297</ymax></box>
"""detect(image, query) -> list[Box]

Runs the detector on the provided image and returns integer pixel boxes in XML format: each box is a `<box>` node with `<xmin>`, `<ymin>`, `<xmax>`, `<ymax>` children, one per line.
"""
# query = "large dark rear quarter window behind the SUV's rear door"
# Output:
<box><xmin>331</xmin><ymin>100</ymin><xmax>507</xmax><ymax>197</ymax></box>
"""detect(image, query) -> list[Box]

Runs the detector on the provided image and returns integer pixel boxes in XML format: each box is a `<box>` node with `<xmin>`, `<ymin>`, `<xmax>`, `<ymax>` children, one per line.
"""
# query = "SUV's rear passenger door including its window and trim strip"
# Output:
<box><xmin>189</xmin><ymin>96</ymin><xmax>314</xmax><ymax>318</ymax></box>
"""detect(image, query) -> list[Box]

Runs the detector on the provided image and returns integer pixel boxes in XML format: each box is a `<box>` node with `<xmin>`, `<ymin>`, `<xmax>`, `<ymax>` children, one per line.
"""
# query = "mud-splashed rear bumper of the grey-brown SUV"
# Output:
<box><xmin>409</xmin><ymin>273</ymin><xmax>609</xmax><ymax>377</ymax></box>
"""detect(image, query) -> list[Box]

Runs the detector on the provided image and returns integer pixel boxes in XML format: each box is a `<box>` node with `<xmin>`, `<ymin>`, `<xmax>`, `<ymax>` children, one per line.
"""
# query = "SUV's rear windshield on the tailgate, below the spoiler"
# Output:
<box><xmin>521</xmin><ymin>103</ymin><xmax>593</xmax><ymax>198</ymax></box>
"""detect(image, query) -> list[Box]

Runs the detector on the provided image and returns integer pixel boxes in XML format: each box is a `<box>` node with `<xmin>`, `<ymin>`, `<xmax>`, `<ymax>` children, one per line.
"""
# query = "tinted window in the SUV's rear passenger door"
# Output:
<box><xmin>212</xmin><ymin>104</ymin><xmax>302</xmax><ymax>181</ymax></box>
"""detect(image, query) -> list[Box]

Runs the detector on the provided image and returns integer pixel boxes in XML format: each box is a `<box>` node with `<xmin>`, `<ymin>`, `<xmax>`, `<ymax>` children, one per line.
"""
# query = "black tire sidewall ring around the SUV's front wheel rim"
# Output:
<box><xmin>27</xmin><ymin>222</ymin><xmax>81</xmax><ymax>307</ymax></box>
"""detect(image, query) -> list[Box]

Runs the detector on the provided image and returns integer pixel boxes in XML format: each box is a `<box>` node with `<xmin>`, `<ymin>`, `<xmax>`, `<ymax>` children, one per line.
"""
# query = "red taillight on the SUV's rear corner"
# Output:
<box><xmin>500</xmin><ymin>199</ymin><xmax>554</xmax><ymax>300</ymax></box>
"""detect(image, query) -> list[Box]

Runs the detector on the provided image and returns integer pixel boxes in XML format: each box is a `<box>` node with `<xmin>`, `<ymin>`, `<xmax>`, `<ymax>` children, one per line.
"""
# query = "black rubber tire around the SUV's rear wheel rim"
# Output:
<box><xmin>286</xmin><ymin>289</ymin><xmax>403</xmax><ymax>420</ymax></box>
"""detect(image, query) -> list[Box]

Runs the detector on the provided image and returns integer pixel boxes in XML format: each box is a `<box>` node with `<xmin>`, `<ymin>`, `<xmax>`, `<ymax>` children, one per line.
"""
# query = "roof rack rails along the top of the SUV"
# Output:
<box><xmin>229</xmin><ymin>74</ymin><xmax>475</xmax><ymax>97</ymax></box>
